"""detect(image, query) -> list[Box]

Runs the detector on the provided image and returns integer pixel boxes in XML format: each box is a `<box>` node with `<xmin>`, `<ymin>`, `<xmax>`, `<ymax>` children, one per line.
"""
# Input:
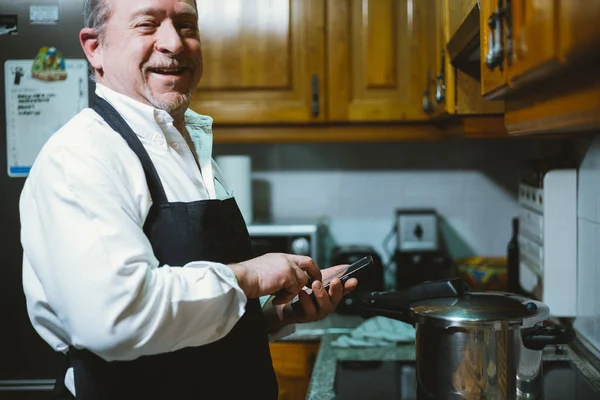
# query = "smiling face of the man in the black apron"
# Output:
<box><xmin>98</xmin><ymin>0</ymin><xmax>202</xmax><ymax>112</ymax></box>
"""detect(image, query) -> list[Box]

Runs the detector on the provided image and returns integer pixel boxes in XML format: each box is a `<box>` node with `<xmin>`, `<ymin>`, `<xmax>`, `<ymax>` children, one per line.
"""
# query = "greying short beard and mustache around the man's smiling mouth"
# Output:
<box><xmin>142</xmin><ymin>59</ymin><xmax>195</xmax><ymax>114</ymax></box>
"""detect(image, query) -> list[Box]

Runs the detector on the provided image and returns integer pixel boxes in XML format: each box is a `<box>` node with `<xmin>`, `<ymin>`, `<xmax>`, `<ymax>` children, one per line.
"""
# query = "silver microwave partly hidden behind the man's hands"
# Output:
<box><xmin>248</xmin><ymin>223</ymin><xmax>326</xmax><ymax>267</ymax></box>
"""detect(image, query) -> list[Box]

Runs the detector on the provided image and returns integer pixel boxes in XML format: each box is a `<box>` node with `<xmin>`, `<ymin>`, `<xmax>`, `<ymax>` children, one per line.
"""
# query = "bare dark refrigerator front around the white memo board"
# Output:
<box><xmin>0</xmin><ymin>0</ymin><xmax>94</xmax><ymax>399</ymax></box>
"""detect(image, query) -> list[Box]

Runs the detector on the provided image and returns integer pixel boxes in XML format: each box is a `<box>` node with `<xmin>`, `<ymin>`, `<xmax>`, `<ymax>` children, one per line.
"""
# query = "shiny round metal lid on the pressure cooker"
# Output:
<box><xmin>410</xmin><ymin>292</ymin><xmax>549</xmax><ymax>328</ymax></box>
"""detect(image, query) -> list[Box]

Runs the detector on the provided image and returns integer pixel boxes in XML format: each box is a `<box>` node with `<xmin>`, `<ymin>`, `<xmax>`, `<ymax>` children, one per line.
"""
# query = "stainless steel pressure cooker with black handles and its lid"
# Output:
<box><xmin>361</xmin><ymin>279</ymin><xmax>575</xmax><ymax>400</ymax></box>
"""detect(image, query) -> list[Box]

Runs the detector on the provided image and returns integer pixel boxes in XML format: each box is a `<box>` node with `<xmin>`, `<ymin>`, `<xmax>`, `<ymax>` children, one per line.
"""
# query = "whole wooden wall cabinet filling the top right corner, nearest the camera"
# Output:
<box><xmin>505</xmin><ymin>0</ymin><xmax>600</xmax><ymax>135</ymax></box>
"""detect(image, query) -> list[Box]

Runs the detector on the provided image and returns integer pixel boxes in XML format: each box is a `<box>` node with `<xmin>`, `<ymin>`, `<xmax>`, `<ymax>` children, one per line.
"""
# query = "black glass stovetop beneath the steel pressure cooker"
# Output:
<box><xmin>334</xmin><ymin>361</ymin><xmax>600</xmax><ymax>400</ymax></box>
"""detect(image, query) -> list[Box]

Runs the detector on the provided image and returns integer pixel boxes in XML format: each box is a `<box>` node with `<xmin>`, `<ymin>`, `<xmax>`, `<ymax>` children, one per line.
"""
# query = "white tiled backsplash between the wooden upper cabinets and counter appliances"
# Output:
<box><xmin>215</xmin><ymin>140</ymin><xmax>539</xmax><ymax>262</ymax></box>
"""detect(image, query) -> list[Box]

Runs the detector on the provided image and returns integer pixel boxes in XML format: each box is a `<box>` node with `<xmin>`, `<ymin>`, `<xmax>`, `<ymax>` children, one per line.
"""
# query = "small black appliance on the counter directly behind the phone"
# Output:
<box><xmin>331</xmin><ymin>245</ymin><xmax>384</xmax><ymax>314</ymax></box>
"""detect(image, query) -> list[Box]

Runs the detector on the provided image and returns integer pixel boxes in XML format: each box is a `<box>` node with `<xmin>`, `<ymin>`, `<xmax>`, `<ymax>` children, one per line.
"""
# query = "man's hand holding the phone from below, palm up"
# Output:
<box><xmin>263</xmin><ymin>264</ymin><xmax>358</xmax><ymax>331</ymax></box>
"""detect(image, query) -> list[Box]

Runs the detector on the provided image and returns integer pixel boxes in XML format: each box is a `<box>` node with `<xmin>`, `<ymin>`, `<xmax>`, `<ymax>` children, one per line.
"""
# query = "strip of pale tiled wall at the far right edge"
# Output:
<box><xmin>575</xmin><ymin>135</ymin><xmax>600</xmax><ymax>349</ymax></box>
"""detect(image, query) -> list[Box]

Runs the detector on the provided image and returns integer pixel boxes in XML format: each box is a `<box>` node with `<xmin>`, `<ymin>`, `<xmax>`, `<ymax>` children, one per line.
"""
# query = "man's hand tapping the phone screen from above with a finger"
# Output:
<box><xmin>229</xmin><ymin>253</ymin><xmax>321</xmax><ymax>305</ymax></box>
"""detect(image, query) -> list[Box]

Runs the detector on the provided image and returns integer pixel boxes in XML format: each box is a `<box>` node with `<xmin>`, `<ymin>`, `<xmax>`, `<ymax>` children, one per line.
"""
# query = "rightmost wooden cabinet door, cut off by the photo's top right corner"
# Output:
<box><xmin>559</xmin><ymin>0</ymin><xmax>600</xmax><ymax>62</ymax></box>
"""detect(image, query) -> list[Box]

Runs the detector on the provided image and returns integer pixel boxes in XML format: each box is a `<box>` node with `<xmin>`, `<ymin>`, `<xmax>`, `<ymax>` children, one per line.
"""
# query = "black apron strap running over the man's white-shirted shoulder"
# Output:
<box><xmin>92</xmin><ymin>96</ymin><xmax>167</xmax><ymax>204</ymax></box>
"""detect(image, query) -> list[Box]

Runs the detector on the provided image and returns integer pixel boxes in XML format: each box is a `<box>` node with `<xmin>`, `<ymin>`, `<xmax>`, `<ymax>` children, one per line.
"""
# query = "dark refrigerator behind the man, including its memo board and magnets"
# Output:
<box><xmin>0</xmin><ymin>0</ymin><xmax>93</xmax><ymax>400</ymax></box>
